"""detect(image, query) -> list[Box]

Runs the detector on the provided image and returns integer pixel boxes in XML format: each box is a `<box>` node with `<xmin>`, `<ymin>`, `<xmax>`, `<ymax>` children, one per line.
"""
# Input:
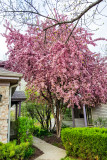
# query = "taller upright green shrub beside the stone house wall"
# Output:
<box><xmin>17</xmin><ymin>117</ymin><xmax>34</xmax><ymax>144</ymax></box>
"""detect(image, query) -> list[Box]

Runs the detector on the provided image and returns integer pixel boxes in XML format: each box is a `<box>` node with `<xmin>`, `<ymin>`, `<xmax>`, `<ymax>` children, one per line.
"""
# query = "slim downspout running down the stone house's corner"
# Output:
<box><xmin>7</xmin><ymin>84</ymin><xmax>18</xmax><ymax>142</ymax></box>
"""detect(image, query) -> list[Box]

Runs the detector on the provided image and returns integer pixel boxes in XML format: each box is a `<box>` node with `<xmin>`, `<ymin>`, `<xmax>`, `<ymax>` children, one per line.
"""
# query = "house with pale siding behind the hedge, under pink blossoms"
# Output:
<box><xmin>72</xmin><ymin>104</ymin><xmax>107</xmax><ymax>127</ymax></box>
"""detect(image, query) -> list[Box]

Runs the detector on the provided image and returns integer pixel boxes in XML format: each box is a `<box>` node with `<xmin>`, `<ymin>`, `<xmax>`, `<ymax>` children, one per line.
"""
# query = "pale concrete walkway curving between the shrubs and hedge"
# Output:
<box><xmin>33</xmin><ymin>137</ymin><xmax>66</xmax><ymax>160</ymax></box>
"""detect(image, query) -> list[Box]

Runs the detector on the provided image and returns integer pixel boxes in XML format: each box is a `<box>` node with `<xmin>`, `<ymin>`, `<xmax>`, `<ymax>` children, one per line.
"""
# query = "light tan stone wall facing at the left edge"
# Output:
<box><xmin>0</xmin><ymin>84</ymin><xmax>9</xmax><ymax>143</ymax></box>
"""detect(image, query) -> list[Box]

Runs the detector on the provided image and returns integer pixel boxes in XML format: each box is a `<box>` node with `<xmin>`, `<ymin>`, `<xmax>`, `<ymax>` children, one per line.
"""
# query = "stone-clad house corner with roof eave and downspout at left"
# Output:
<box><xmin>0</xmin><ymin>61</ymin><xmax>22</xmax><ymax>143</ymax></box>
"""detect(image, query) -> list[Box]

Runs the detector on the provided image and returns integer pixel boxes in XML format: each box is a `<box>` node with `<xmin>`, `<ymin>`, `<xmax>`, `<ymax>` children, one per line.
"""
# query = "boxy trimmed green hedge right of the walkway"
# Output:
<box><xmin>61</xmin><ymin>127</ymin><xmax>107</xmax><ymax>160</ymax></box>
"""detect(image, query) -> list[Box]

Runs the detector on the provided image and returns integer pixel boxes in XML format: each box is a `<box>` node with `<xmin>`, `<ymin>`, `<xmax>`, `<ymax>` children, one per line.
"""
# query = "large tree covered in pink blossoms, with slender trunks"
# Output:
<box><xmin>4</xmin><ymin>15</ymin><xmax>107</xmax><ymax>136</ymax></box>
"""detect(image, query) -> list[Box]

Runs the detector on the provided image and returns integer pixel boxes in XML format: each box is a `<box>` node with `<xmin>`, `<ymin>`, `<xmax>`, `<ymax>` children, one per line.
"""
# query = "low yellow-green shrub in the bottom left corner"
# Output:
<box><xmin>0</xmin><ymin>141</ymin><xmax>33</xmax><ymax>160</ymax></box>
